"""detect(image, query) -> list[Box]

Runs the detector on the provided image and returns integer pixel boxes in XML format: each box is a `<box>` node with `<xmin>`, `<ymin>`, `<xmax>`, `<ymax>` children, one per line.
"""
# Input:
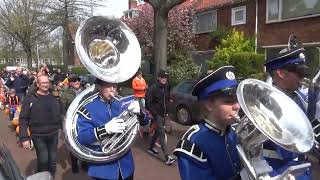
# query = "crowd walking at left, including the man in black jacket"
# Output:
<box><xmin>0</xmin><ymin>65</ymin><xmax>92</xmax><ymax>175</ymax></box>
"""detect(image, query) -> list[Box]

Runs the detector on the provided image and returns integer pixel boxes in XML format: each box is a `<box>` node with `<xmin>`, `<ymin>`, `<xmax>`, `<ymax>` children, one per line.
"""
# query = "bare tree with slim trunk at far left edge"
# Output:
<box><xmin>0</xmin><ymin>0</ymin><xmax>55</xmax><ymax>68</ymax></box>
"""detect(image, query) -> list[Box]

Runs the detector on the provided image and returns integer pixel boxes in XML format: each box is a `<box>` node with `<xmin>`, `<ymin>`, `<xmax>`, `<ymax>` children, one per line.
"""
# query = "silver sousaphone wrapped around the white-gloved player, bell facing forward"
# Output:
<box><xmin>63</xmin><ymin>16</ymin><xmax>141</xmax><ymax>163</ymax></box>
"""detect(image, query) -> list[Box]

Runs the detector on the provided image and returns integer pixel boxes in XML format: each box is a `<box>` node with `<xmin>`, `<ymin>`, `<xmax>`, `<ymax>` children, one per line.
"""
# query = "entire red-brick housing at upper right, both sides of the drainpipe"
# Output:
<box><xmin>194</xmin><ymin>0</ymin><xmax>320</xmax><ymax>70</ymax></box>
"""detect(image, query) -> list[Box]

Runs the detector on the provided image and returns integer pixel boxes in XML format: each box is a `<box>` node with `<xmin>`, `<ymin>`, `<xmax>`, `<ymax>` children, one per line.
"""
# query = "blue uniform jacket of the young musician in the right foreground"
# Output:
<box><xmin>174</xmin><ymin>123</ymin><xmax>241</xmax><ymax>180</ymax></box>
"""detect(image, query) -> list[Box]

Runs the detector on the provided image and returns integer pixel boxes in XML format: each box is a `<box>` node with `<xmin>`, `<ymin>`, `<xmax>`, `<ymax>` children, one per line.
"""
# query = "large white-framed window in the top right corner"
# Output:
<box><xmin>266</xmin><ymin>0</ymin><xmax>320</xmax><ymax>22</ymax></box>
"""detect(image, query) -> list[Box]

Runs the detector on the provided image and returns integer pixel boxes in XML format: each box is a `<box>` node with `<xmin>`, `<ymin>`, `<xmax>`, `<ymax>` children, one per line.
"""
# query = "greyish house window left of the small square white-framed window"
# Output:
<box><xmin>193</xmin><ymin>10</ymin><xmax>217</xmax><ymax>34</ymax></box>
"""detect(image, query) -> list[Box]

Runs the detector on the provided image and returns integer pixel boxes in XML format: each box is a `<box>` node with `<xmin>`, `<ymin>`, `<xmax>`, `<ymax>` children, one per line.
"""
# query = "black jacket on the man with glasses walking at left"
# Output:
<box><xmin>19</xmin><ymin>93</ymin><xmax>63</xmax><ymax>142</ymax></box>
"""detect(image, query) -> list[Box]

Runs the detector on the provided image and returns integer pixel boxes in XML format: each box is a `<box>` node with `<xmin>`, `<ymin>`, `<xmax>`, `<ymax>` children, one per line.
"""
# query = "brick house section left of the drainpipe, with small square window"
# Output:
<box><xmin>193</xmin><ymin>0</ymin><xmax>255</xmax><ymax>51</ymax></box>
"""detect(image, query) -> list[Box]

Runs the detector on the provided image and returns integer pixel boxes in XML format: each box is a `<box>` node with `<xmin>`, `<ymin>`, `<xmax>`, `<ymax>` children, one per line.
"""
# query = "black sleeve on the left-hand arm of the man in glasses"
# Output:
<box><xmin>19</xmin><ymin>96</ymin><xmax>32</xmax><ymax>142</ymax></box>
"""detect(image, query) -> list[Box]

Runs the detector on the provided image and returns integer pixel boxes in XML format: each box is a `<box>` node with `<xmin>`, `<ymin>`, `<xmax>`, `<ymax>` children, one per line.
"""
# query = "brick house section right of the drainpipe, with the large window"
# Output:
<box><xmin>257</xmin><ymin>0</ymin><xmax>320</xmax><ymax>70</ymax></box>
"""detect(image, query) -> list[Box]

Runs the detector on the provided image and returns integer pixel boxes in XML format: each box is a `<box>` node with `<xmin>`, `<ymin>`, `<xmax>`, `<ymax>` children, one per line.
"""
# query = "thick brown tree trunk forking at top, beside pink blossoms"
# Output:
<box><xmin>146</xmin><ymin>0</ymin><xmax>186</xmax><ymax>74</ymax></box>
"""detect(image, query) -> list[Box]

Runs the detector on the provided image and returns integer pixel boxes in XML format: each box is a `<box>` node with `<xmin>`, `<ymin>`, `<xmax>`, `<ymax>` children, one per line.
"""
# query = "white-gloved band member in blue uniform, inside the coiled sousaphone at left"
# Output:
<box><xmin>77</xmin><ymin>79</ymin><xmax>147</xmax><ymax>180</ymax></box>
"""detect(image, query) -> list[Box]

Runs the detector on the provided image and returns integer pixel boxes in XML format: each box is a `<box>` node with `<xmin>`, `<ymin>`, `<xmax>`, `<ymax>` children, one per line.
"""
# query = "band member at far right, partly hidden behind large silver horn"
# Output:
<box><xmin>263</xmin><ymin>40</ymin><xmax>312</xmax><ymax>180</ymax></box>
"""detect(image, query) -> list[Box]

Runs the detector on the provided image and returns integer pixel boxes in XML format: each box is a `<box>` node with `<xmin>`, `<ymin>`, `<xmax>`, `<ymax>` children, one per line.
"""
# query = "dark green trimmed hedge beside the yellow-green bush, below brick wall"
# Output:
<box><xmin>229</xmin><ymin>52</ymin><xmax>265</xmax><ymax>80</ymax></box>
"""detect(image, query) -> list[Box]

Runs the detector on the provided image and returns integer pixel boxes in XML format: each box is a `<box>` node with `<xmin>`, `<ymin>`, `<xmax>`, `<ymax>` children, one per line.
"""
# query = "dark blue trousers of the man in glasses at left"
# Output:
<box><xmin>31</xmin><ymin>133</ymin><xmax>58</xmax><ymax>175</ymax></box>
